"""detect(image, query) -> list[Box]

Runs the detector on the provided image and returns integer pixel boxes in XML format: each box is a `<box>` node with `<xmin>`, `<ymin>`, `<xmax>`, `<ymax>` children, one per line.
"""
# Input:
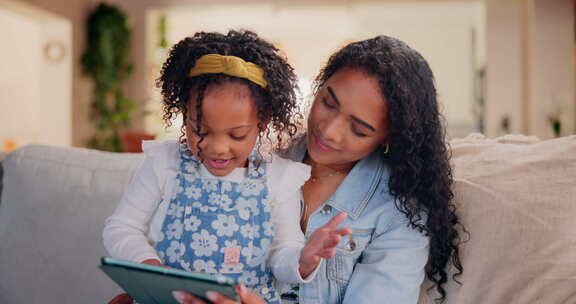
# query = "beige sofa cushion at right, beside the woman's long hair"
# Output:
<box><xmin>421</xmin><ymin>135</ymin><xmax>576</xmax><ymax>304</ymax></box>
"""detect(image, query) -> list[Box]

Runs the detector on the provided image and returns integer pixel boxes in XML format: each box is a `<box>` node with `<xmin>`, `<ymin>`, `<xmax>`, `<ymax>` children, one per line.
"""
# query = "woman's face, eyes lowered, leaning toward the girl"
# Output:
<box><xmin>307</xmin><ymin>68</ymin><xmax>388</xmax><ymax>165</ymax></box>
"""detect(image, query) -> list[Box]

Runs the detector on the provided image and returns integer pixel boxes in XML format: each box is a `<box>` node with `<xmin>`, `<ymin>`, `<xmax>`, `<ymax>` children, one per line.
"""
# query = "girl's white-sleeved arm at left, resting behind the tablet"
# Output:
<box><xmin>103</xmin><ymin>157</ymin><xmax>162</xmax><ymax>263</ymax></box>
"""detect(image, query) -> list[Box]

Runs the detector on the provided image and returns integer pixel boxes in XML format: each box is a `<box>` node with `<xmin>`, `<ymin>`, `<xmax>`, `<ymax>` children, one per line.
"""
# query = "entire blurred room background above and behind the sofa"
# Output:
<box><xmin>0</xmin><ymin>0</ymin><xmax>576</xmax><ymax>151</ymax></box>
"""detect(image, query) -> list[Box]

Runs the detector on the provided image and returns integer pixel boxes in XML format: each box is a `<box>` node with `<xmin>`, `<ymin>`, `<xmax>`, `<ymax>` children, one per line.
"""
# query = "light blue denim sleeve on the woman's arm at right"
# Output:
<box><xmin>343</xmin><ymin>216</ymin><xmax>429</xmax><ymax>304</ymax></box>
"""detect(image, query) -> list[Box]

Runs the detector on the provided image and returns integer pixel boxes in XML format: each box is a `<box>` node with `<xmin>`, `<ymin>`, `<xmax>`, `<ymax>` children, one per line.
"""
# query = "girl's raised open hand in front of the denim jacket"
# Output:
<box><xmin>299</xmin><ymin>212</ymin><xmax>352</xmax><ymax>278</ymax></box>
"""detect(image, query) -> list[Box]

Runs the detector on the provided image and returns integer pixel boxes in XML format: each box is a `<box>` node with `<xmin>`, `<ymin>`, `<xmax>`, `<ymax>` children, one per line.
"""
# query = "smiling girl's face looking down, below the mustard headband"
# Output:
<box><xmin>186</xmin><ymin>82</ymin><xmax>259</xmax><ymax>176</ymax></box>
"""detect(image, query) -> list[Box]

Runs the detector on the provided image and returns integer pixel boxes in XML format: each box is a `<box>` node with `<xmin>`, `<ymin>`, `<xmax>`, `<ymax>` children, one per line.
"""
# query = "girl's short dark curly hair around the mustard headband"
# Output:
<box><xmin>156</xmin><ymin>30</ymin><xmax>302</xmax><ymax>153</ymax></box>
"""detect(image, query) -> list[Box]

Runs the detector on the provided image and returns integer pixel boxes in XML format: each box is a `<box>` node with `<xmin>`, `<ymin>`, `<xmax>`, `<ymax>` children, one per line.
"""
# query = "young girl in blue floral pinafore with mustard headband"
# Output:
<box><xmin>103</xmin><ymin>31</ymin><xmax>350</xmax><ymax>303</ymax></box>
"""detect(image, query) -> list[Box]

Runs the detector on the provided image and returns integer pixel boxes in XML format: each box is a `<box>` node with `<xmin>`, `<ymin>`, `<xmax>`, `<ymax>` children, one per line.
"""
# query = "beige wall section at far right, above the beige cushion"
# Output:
<box><xmin>486</xmin><ymin>0</ymin><xmax>576</xmax><ymax>138</ymax></box>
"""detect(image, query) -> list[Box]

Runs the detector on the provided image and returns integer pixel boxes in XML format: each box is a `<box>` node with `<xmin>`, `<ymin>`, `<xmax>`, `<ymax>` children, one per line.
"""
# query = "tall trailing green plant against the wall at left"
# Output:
<box><xmin>82</xmin><ymin>3</ymin><xmax>136</xmax><ymax>152</ymax></box>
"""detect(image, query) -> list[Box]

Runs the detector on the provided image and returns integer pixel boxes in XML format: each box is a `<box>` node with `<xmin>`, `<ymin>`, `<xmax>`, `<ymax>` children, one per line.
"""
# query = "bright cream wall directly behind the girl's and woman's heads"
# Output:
<box><xmin>147</xmin><ymin>1</ymin><xmax>484</xmax><ymax>137</ymax></box>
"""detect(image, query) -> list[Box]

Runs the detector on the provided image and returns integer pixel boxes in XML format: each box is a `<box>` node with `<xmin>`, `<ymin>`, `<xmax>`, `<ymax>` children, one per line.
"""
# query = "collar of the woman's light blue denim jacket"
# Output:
<box><xmin>285</xmin><ymin>136</ymin><xmax>388</xmax><ymax>220</ymax></box>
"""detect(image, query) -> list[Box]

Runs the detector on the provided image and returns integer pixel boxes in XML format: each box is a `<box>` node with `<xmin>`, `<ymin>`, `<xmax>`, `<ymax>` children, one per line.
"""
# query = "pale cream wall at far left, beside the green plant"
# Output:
<box><xmin>0</xmin><ymin>0</ymin><xmax>71</xmax><ymax>146</ymax></box>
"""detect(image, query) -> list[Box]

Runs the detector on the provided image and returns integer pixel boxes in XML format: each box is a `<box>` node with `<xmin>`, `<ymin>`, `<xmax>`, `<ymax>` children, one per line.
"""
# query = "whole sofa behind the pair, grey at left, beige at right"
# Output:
<box><xmin>0</xmin><ymin>135</ymin><xmax>576</xmax><ymax>304</ymax></box>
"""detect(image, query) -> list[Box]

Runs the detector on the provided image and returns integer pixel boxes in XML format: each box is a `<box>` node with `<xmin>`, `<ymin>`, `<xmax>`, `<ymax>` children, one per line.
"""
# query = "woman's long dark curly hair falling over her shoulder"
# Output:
<box><xmin>315</xmin><ymin>36</ymin><xmax>465</xmax><ymax>302</ymax></box>
